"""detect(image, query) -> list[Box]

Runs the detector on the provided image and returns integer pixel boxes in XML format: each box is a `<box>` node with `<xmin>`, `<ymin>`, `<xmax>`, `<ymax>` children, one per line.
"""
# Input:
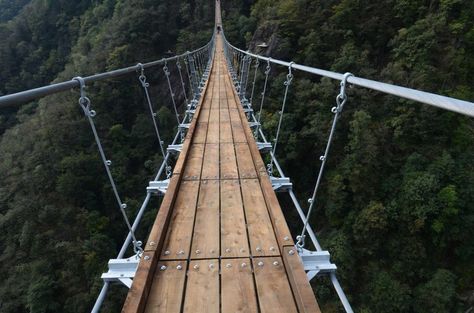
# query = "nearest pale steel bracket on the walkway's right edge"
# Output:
<box><xmin>298</xmin><ymin>249</ymin><xmax>337</xmax><ymax>280</ymax></box>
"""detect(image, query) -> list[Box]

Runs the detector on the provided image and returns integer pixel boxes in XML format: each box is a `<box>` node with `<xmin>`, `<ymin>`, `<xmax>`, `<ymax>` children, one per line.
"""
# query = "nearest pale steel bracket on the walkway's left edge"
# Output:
<box><xmin>101</xmin><ymin>255</ymin><xmax>140</xmax><ymax>288</ymax></box>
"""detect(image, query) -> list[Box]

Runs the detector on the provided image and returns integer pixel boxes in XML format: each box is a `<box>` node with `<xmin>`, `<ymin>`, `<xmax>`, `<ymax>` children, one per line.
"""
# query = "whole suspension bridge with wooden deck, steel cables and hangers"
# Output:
<box><xmin>0</xmin><ymin>1</ymin><xmax>474</xmax><ymax>313</ymax></box>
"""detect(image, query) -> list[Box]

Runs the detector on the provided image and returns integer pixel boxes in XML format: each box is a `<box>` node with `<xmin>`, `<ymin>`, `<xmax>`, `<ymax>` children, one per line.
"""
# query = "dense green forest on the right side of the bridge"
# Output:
<box><xmin>224</xmin><ymin>0</ymin><xmax>474</xmax><ymax>313</ymax></box>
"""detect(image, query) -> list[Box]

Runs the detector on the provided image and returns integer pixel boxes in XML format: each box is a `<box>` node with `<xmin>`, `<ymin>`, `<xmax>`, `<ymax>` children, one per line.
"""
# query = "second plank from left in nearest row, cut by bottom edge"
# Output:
<box><xmin>183</xmin><ymin>259</ymin><xmax>219</xmax><ymax>313</ymax></box>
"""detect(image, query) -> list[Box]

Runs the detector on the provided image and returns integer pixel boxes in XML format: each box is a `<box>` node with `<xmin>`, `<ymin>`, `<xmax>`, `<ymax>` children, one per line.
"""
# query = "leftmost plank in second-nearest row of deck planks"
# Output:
<box><xmin>161</xmin><ymin>181</ymin><xmax>199</xmax><ymax>260</ymax></box>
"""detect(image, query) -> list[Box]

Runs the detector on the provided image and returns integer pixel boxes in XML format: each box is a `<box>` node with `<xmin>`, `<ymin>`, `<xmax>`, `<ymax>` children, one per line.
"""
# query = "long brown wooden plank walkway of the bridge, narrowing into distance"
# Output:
<box><xmin>122</xmin><ymin>15</ymin><xmax>320</xmax><ymax>313</ymax></box>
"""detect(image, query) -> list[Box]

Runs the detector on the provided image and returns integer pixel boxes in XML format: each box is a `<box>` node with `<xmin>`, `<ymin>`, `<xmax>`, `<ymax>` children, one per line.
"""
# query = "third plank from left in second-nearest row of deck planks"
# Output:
<box><xmin>221</xmin><ymin>180</ymin><xmax>249</xmax><ymax>257</ymax></box>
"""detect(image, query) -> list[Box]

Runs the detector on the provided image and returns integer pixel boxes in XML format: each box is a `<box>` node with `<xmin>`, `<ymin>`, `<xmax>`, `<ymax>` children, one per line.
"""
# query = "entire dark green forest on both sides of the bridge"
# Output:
<box><xmin>0</xmin><ymin>0</ymin><xmax>474</xmax><ymax>313</ymax></box>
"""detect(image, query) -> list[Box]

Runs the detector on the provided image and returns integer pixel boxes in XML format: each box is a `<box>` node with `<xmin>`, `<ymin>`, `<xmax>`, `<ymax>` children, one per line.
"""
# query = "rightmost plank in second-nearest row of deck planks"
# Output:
<box><xmin>240</xmin><ymin>179</ymin><xmax>280</xmax><ymax>256</ymax></box>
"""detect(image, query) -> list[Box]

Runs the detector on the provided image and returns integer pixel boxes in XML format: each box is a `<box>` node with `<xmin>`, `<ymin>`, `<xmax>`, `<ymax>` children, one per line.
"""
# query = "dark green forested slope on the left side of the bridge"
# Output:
<box><xmin>0</xmin><ymin>0</ymin><xmax>214</xmax><ymax>313</ymax></box>
